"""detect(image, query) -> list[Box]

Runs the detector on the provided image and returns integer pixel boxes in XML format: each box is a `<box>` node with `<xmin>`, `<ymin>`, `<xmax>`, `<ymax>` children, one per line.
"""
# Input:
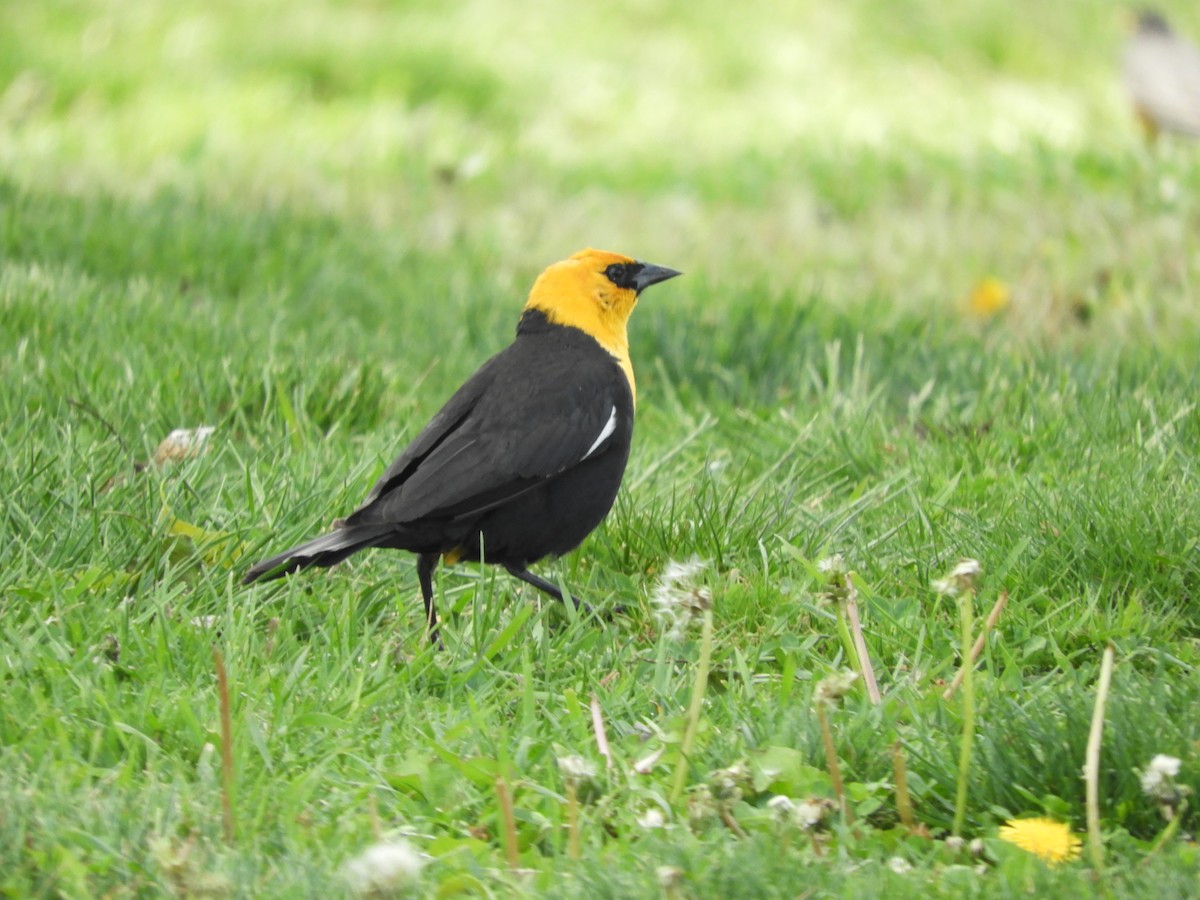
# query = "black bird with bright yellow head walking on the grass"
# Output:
<box><xmin>244</xmin><ymin>250</ymin><xmax>679</xmax><ymax>642</ymax></box>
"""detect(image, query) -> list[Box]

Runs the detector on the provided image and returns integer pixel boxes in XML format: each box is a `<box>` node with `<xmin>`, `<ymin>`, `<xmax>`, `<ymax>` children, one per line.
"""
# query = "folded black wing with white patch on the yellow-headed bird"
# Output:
<box><xmin>348</xmin><ymin>334</ymin><xmax>632</xmax><ymax>524</ymax></box>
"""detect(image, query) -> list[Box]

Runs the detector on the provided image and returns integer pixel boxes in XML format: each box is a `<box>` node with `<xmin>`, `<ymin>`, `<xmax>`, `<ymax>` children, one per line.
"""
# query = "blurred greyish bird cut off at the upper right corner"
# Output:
<box><xmin>1123</xmin><ymin>12</ymin><xmax>1200</xmax><ymax>138</ymax></box>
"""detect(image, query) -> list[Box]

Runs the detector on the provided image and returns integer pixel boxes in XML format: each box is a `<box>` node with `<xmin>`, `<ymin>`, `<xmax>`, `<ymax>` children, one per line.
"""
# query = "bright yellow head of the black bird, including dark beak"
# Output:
<box><xmin>526</xmin><ymin>250</ymin><xmax>679</xmax><ymax>395</ymax></box>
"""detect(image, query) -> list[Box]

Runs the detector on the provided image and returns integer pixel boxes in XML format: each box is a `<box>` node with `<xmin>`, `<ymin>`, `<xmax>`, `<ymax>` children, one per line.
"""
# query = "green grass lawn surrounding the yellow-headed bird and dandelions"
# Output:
<box><xmin>0</xmin><ymin>0</ymin><xmax>1200</xmax><ymax>898</ymax></box>
